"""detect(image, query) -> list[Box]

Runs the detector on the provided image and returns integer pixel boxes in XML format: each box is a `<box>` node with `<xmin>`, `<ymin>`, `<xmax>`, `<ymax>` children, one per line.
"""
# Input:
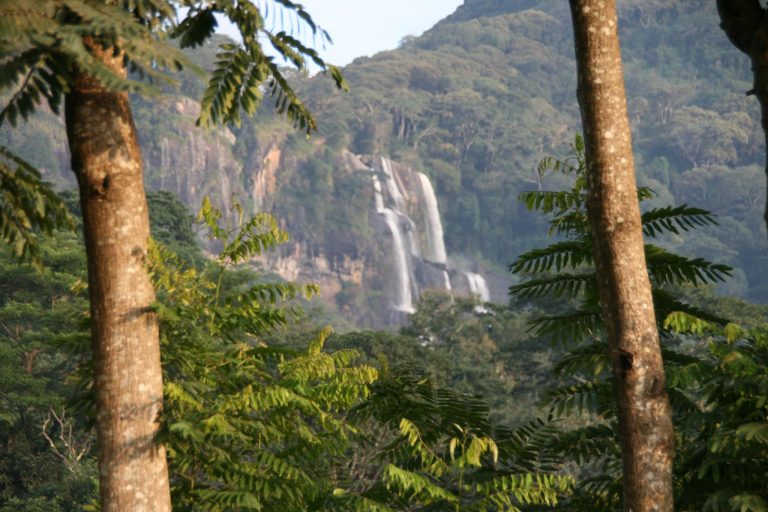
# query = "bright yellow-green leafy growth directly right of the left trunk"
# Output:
<box><xmin>151</xmin><ymin>201</ymin><xmax>377</xmax><ymax>510</ymax></box>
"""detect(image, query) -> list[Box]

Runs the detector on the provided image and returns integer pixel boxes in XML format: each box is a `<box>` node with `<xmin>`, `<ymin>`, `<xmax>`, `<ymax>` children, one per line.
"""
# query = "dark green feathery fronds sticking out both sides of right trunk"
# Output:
<box><xmin>509</xmin><ymin>136</ymin><xmax>732</xmax><ymax>343</ymax></box>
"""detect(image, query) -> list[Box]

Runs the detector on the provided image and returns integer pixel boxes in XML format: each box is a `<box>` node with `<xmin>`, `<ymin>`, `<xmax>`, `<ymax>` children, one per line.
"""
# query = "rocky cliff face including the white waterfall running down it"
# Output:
<box><xmin>9</xmin><ymin>96</ymin><xmax>506</xmax><ymax>328</ymax></box>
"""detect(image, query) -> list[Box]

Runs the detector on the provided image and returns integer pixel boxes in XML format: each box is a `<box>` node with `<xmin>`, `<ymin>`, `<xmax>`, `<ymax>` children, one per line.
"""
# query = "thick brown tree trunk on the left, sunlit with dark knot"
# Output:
<box><xmin>66</xmin><ymin>40</ymin><xmax>171</xmax><ymax>512</ymax></box>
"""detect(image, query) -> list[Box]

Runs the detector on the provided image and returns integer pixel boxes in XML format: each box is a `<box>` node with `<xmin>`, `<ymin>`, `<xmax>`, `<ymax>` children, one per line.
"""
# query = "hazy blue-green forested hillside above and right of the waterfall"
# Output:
<box><xmin>296</xmin><ymin>1</ymin><xmax>766</xmax><ymax>300</ymax></box>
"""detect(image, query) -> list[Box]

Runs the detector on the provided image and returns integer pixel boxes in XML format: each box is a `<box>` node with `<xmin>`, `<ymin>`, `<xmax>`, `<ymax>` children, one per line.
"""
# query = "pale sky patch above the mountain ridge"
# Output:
<box><xmin>219</xmin><ymin>0</ymin><xmax>462</xmax><ymax>66</ymax></box>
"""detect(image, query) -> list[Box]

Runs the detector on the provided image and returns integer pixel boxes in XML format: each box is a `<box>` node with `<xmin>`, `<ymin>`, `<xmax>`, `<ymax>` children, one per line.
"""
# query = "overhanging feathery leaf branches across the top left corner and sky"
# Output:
<box><xmin>0</xmin><ymin>0</ymin><xmax>347</xmax><ymax>266</ymax></box>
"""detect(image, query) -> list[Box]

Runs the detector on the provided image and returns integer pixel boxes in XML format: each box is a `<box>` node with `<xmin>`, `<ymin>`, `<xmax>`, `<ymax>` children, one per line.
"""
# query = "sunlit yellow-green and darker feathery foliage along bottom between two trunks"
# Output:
<box><xmin>152</xmin><ymin>202</ymin><xmax>571</xmax><ymax>510</ymax></box>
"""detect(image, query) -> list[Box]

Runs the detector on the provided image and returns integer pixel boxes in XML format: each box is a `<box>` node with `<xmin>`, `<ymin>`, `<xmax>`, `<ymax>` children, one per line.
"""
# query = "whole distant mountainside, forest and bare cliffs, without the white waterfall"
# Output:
<box><xmin>5</xmin><ymin>0</ymin><xmax>768</xmax><ymax>325</ymax></box>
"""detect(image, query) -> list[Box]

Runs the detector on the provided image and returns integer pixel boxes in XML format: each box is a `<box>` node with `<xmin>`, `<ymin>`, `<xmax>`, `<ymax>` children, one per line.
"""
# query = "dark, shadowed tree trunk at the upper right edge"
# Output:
<box><xmin>717</xmin><ymin>0</ymin><xmax>768</xmax><ymax>240</ymax></box>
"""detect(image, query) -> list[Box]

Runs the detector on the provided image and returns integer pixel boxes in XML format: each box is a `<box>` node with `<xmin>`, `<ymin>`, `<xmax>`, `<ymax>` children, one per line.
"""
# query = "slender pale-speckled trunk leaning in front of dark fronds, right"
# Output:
<box><xmin>570</xmin><ymin>0</ymin><xmax>674</xmax><ymax>512</ymax></box>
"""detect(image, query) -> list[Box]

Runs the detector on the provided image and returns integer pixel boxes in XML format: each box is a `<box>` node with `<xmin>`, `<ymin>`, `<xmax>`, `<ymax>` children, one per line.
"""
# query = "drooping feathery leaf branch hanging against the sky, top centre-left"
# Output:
<box><xmin>177</xmin><ymin>0</ymin><xmax>347</xmax><ymax>134</ymax></box>
